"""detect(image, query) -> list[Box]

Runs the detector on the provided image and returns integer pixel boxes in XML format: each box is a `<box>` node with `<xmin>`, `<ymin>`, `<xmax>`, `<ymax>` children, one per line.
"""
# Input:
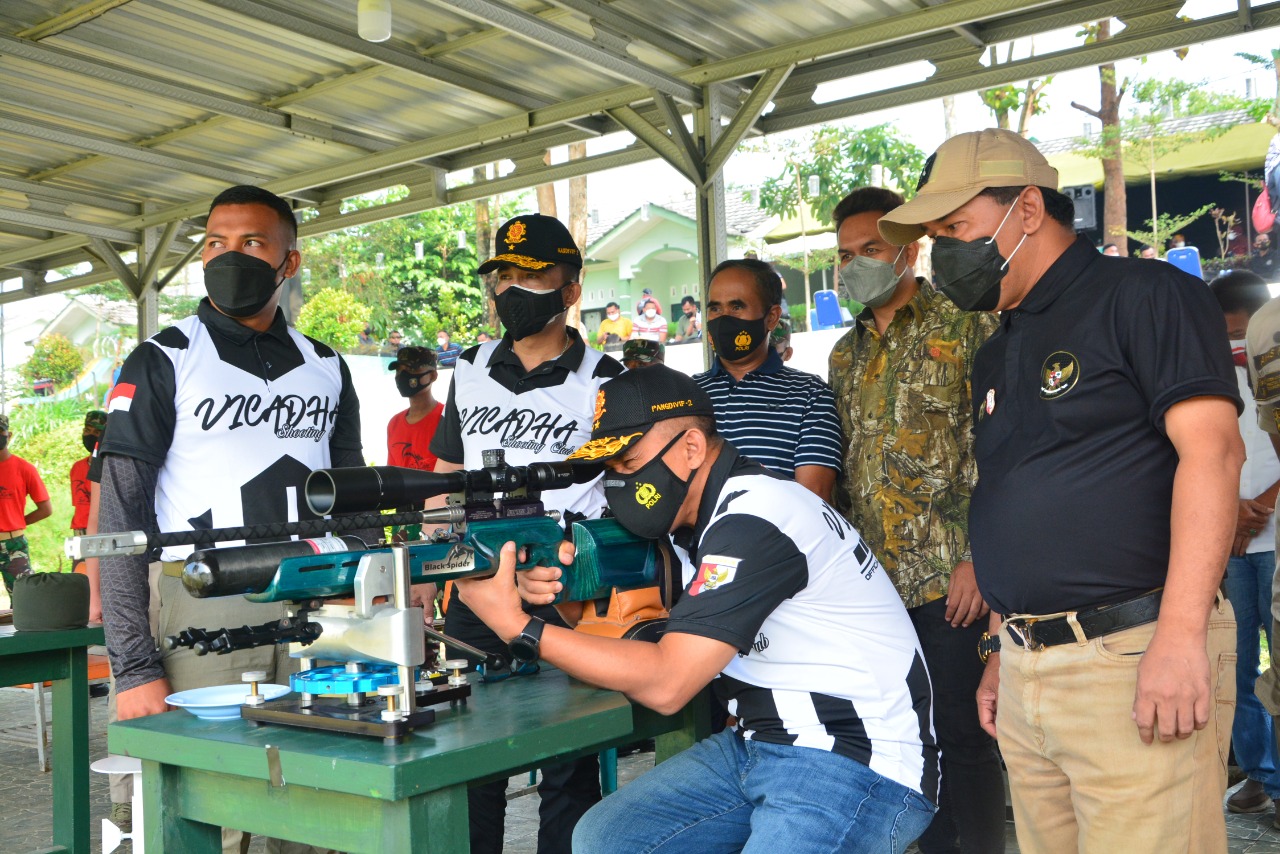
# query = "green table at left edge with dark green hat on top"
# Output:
<box><xmin>0</xmin><ymin>625</ymin><xmax>106</xmax><ymax>854</ymax></box>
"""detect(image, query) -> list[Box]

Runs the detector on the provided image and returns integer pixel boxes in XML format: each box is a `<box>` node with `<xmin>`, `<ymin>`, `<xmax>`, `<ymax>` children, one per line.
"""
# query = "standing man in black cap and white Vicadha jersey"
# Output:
<box><xmin>431</xmin><ymin>214</ymin><xmax>622</xmax><ymax>854</ymax></box>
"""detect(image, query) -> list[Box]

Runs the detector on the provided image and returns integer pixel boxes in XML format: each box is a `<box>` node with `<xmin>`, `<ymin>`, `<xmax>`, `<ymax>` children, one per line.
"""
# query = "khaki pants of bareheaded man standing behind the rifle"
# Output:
<box><xmin>156</xmin><ymin>575</ymin><xmax>325</xmax><ymax>854</ymax></box>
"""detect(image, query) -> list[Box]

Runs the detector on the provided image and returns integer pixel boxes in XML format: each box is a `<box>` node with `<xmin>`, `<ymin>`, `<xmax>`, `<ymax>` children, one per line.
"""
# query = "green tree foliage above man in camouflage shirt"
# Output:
<box><xmin>760</xmin><ymin>124</ymin><xmax>924</xmax><ymax>223</ymax></box>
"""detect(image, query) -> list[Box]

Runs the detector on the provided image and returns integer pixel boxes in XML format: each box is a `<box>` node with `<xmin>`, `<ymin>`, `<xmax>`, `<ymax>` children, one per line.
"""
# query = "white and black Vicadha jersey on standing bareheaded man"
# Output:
<box><xmin>99</xmin><ymin>301</ymin><xmax>360</xmax><ymax>561</ymax></box>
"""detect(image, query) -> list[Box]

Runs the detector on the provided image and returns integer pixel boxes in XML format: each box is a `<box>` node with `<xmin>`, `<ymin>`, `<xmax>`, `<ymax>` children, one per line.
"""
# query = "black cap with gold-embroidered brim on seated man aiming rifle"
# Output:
<box><xmin>568</xmin><ymin>365</ymin><xmax>716</xmax><ymax>461</ymax></box>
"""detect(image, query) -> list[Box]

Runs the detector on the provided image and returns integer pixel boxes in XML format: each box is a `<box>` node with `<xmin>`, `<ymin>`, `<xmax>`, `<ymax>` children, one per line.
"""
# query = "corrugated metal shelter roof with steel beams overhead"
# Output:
<box><xmin>0</xmin><ymin>0</ymin><xmax>1280</xmax><ymax>301</ymax></box>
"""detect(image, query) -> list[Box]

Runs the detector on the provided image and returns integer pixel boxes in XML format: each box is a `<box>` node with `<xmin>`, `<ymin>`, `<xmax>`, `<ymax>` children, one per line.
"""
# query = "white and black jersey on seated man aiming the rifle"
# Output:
<box><xmin>667</xmin><ymin>443</ymin><xmax>938</xmax><ymax>802</ymax></box>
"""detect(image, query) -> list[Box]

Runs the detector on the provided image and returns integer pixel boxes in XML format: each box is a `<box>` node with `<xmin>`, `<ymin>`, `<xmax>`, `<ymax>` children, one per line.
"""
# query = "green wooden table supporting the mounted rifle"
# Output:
<box><xmin>108</xmin><ymin>667</ymin><xmax>709</xmax><ymax>854</ymax></box>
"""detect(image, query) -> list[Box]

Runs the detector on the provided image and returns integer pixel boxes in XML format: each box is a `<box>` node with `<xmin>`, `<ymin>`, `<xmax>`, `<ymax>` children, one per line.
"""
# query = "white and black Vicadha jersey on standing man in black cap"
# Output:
<box><xmin>431</xmin><ymin>329</ymin><xmax>622</xmax><ymax>516</ymax></box>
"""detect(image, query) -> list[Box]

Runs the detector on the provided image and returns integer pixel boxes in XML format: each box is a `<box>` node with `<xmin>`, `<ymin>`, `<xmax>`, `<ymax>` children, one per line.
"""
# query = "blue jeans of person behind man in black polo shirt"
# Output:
<box><xmin>1226</xmin><ymin>552</ymin><xmax>1280</xmax><ymax>798</ymax></box>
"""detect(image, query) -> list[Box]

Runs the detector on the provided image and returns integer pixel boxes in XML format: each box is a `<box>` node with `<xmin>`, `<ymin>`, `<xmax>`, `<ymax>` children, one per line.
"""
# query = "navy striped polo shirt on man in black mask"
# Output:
<box><xmin>694</xmin><ymin>347</ymin><xmax>844</xmax><ymax>478</ymax></box>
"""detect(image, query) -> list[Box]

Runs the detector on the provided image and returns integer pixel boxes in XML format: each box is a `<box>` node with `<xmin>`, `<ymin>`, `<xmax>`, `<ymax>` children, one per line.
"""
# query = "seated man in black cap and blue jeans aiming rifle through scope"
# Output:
<box><xmin>458</xmin><ymin>365</ymin><xmax>938</xmax><ymax>854</ymax></box>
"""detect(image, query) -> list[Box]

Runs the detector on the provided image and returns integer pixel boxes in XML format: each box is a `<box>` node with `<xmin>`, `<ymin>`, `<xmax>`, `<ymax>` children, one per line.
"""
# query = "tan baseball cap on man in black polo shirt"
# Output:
<box><xmin>879</xmin><ymin>128</ymin><xmax>1057</xmax><ymax>246</ymax></box>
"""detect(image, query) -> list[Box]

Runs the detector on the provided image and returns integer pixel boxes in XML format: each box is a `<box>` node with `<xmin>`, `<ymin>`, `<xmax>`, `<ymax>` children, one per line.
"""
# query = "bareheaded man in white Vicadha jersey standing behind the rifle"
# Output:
<box><xmin>99</xmin><ymin>187</ymin><xmax>364</xmax><ymax>851</ymax></box>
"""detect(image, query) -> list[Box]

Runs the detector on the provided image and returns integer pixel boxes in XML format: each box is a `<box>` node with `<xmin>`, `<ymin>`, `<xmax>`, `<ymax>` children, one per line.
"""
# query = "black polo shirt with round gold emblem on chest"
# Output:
<box><xmin>969</xmin><ymin>239</ymin><xmax>1243</xmax><ymax>615</ymax></box>
